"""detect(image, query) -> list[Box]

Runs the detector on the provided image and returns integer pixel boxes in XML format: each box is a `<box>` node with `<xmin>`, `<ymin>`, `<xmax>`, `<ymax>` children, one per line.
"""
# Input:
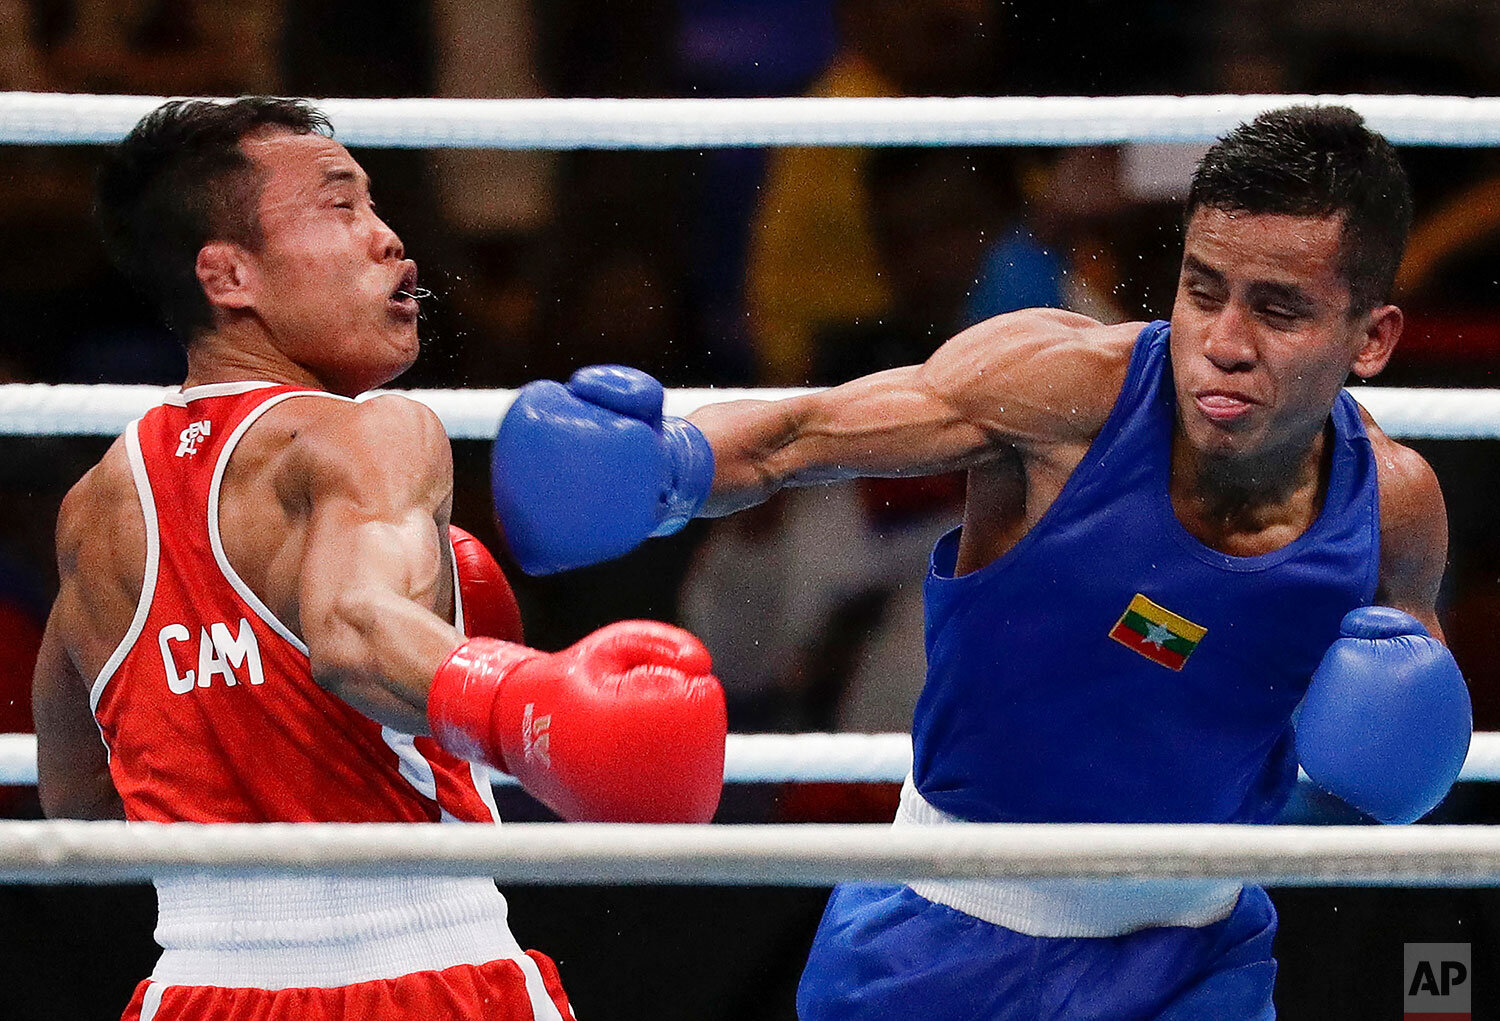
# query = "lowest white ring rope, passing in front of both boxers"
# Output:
<box><xmin>0</xmin><ymin>822</ymin><xmax>1500</xmax><ymax>886</ymax></box>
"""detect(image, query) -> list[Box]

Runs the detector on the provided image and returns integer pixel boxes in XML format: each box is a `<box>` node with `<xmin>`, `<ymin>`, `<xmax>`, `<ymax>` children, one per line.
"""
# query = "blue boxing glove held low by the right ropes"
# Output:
<box><xmin>1296</xmin><ymin>606</ymin><xmax>1475</xmax><ymax>823</ymax></box>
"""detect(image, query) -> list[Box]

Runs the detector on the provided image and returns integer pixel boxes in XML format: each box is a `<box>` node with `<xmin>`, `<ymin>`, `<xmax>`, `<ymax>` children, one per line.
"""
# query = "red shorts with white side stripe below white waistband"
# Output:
<box><xmin>122</xmin><ymin>951</ymin><xmax>573</xmax><ymax>1021</ymax></box>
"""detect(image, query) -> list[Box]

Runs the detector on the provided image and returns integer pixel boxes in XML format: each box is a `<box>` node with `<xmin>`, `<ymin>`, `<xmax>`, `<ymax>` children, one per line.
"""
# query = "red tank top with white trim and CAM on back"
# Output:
<box><xmin>90</xmin><ymin>382</ymin><xmax>495</xmax><ymax>823</ymax></box>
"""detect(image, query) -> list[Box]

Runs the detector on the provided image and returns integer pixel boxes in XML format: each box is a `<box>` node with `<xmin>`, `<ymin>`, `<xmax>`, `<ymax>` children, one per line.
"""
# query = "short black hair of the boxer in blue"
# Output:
<box><xmin>1187</xmin><ymin>106</ymin><xmax>1412</xmax><ymax>315</ymax></box>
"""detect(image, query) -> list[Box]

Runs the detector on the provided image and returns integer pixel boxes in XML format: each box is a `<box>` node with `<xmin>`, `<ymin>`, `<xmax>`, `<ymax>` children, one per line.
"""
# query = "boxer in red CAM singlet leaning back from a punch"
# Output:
<box><xmin>35</xmin><ymin>99</ymin><xmax>725</xmax><ymax>1021</ymax></box>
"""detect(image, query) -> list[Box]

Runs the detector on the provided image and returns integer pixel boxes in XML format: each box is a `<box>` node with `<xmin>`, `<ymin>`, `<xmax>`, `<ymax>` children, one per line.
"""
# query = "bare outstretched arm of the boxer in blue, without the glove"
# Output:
<box><xmin>690</xmin><ymin>309</ymin><xmax>1140</xmax><ymax>516</ymax></box>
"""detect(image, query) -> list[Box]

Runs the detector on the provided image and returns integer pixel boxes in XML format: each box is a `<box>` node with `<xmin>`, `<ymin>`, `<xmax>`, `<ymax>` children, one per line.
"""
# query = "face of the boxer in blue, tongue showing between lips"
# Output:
<box><xmin>1172</xmin><ymin>208</ymin><xmax>1401</xmax><ymax>470</ymax></box>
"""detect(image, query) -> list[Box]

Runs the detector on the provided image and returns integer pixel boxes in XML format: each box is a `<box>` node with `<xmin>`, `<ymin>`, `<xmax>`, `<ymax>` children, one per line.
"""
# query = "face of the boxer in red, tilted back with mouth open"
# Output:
<box><xmin>242</xmin><ymin>132</ymin><xmax>417</xmax><ymax>393</ymax></box>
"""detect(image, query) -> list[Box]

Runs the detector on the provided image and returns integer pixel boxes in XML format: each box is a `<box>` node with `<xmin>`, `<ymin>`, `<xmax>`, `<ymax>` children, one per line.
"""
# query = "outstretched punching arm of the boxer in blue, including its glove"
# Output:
<box><xmin>492</xmin><ymin>309</ymin><xmax>1140</xmax><ymax>574</ymax></box>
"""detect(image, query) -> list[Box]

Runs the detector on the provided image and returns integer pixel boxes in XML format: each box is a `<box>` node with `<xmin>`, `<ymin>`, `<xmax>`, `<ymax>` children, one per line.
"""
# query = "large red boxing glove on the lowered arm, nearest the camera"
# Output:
<box><xmin>428</xmin><ymin>621</ymin><xmax>728</xmax><ymax>823</ymax></box>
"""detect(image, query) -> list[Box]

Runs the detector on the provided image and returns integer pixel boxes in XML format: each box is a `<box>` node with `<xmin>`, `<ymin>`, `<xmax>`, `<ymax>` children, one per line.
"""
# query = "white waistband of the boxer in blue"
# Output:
<box><xmin>896</xmin><ymin>777</ymin><xmax>1242</xmax><ymax>937</ymax></box>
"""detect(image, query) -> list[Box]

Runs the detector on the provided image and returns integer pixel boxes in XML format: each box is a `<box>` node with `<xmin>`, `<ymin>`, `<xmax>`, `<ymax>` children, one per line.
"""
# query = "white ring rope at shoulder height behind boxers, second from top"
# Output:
<box><xmin>0</xmin><ymin>382</ymin><xmax>1500</xmax><ymax>439</ymax></box>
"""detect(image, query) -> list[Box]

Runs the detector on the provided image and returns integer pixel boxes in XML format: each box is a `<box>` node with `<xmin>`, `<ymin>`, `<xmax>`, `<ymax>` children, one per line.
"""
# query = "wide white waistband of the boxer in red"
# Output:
<box><xmin>152</xmin><ymin>874</ymin><xmax>530</xmax><ymax>990</ymax></box>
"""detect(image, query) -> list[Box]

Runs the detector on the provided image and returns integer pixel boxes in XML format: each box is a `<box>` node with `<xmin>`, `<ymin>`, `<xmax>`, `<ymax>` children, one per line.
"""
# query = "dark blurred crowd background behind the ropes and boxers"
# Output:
<box><xmin>0</xmin><ymin>0</ymin><xmax>1500</xmax><ymax>1018</ymax></box>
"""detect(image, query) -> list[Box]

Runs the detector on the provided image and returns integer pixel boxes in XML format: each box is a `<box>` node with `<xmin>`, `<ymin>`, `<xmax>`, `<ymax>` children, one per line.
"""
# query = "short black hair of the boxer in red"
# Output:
<box><xmin>95</xmin><ymin>96</ymin><xmax>333</xmax><ymax>343</ymax></box>
